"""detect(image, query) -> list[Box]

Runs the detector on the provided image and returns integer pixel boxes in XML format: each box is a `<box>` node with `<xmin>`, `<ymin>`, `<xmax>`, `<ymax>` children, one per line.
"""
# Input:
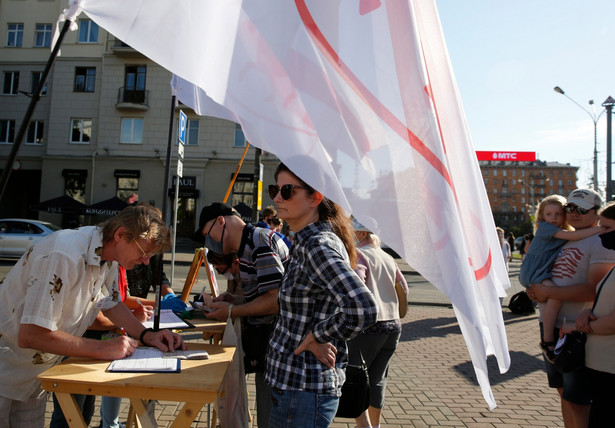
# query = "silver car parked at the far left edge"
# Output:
<box><xmin>0</xmin><ymin>218</ymin><xmax>61</xmax><ymax>258</ymax></box>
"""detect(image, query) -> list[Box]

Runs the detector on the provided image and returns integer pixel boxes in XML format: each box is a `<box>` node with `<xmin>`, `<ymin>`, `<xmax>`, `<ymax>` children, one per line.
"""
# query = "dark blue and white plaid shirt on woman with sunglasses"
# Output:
<box><xmin>265</xmin><ymin>222</ymin><xmax>378</xmax><ymax>397</ymax></box>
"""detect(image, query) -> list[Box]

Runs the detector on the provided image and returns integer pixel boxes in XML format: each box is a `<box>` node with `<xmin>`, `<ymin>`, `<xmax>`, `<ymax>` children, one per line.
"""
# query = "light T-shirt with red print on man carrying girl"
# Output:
<box><xmin>539</xmin><ymin>235</ymin><xmax>615</xmax><ymax>327</ymax></box>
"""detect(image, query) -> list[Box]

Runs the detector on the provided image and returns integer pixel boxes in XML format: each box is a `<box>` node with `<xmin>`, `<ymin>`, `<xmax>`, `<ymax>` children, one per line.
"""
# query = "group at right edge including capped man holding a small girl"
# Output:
<box><xmin>506</xmin><ymin>189</ymin><xmax>615</xmax><ymax>427</ymax></box>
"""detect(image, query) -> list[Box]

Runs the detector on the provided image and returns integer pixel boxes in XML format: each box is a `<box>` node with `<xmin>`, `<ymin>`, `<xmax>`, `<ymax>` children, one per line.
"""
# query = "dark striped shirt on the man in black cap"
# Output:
<box><xmin>237</xmin><ymin>224</ymin><xmax>288</xmax><ymax>324</ymax></box>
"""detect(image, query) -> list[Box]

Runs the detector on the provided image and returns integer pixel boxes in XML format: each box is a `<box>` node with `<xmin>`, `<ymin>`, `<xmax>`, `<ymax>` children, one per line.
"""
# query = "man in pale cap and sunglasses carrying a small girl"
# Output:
<box><xmin>528</xmin><ymin>189</ymin><xmax>615</xmax><ymax>427</ymax></box>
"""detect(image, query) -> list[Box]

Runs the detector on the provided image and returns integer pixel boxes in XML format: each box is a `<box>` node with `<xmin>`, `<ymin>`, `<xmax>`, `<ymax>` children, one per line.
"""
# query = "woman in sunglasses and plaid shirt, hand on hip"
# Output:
<box><xmin>265</xmin><ymin>164</ymin><xmax>378</xmax><ymax>428</ymax></box>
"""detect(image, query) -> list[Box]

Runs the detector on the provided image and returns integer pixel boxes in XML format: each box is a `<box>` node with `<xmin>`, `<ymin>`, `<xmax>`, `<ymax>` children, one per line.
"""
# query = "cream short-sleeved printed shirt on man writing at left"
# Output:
<box><xmin>0</xmin><ymin>226</ymin><xmax>120</xmax><ymax>400</ymax></box>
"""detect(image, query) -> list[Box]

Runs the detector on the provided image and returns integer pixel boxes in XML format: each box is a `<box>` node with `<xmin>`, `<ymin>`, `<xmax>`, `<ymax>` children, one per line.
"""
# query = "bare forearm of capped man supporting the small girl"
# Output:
<box><xmin>531</xmin><ymin>263</ymin><xmax>613</xmax><ymax>302</ymax></box>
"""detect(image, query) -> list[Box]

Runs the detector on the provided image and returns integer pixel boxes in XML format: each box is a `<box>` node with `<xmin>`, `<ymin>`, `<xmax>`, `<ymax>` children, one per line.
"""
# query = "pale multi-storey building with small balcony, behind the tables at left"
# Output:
<box><xmin>0</xmin><ymin>0</ymin><xmax>278</xmax><ymax>236</ymax></box>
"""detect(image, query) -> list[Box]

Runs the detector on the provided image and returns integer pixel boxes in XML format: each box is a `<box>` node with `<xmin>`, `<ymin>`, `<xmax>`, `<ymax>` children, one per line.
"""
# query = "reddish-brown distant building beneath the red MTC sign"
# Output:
<box><xmin>479</xmin><ymin>160</ymin><xmax>579</xmax><ymax>229</ymax></box>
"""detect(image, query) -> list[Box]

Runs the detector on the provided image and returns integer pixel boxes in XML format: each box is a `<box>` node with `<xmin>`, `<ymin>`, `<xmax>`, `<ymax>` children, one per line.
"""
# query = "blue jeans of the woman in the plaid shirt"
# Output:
<box><xmin>269</xmin><ymin>388</ymin><xmax>339</xmax><ymax>428</ymax></box>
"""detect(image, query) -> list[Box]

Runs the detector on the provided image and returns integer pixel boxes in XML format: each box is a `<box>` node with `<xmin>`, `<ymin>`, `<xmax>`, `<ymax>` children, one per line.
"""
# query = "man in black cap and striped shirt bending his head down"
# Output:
<box><xmin>193</xmin><ymin>202</ymin><xmax>289</xmax><ymax>428</ymax></box>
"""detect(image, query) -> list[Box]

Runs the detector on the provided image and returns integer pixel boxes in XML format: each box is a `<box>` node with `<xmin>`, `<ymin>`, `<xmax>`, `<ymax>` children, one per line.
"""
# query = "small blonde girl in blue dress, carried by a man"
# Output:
<box><xmin>519</xmin><ymin>195</ymin><xmax>600</xmax><ymax>362</ymax></box>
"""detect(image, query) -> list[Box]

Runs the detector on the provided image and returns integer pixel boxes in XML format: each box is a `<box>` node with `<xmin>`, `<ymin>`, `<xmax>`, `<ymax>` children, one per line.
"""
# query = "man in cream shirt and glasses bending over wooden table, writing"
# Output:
<box><xmin>0</xmin><ymin>205</ymin><xmax>185</xmax><ymax>428</ymax></box>
